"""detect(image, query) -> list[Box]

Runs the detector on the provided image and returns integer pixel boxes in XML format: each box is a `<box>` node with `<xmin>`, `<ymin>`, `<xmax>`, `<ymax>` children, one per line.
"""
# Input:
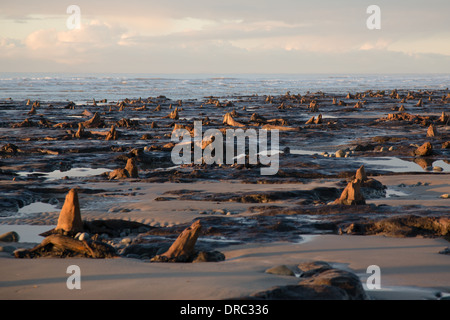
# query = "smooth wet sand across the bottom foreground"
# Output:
<box><xmin>0</xmin><ymin>235</ymin><xmax>450</xmax><ymax>300</ymax></box>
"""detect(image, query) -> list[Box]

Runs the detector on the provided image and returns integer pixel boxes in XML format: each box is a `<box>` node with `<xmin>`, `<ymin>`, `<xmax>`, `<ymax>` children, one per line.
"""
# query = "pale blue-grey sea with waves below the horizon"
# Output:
<box><xmin>0</xmin><ymin>72</ymin><xmax>450</xmax><ymax>103</ymax></box>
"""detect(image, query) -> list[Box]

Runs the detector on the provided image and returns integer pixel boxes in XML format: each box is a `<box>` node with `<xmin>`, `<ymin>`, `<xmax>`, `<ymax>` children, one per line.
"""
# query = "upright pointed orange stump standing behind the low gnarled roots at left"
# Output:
<box><xmin>55</xmin><ymin>189</ymin><xmax>83</xmax><ymax>235</ymax></box>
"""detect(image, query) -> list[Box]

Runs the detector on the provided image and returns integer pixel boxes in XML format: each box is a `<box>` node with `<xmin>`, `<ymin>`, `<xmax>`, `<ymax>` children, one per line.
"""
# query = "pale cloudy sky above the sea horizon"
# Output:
<box><xmin>0</xmin><ymin>0</ymin><xmax>450</xmax><ymax>74</ymax></box>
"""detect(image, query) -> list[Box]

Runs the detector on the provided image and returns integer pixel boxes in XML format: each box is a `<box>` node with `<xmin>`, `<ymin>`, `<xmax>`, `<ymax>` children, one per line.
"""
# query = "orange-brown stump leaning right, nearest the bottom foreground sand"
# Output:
<box><xmin>151</xmin><ymin>220</ymin><xmax>202</xmax><ymax>262</ymax></box>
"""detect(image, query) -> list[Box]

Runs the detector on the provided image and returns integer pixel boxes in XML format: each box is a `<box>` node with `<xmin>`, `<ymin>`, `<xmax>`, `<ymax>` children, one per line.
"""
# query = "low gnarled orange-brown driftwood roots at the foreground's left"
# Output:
<box><xmin>14</xmin><ymin>234</ymin><xmax>117</xmax><ymax>258</ymax></box>
